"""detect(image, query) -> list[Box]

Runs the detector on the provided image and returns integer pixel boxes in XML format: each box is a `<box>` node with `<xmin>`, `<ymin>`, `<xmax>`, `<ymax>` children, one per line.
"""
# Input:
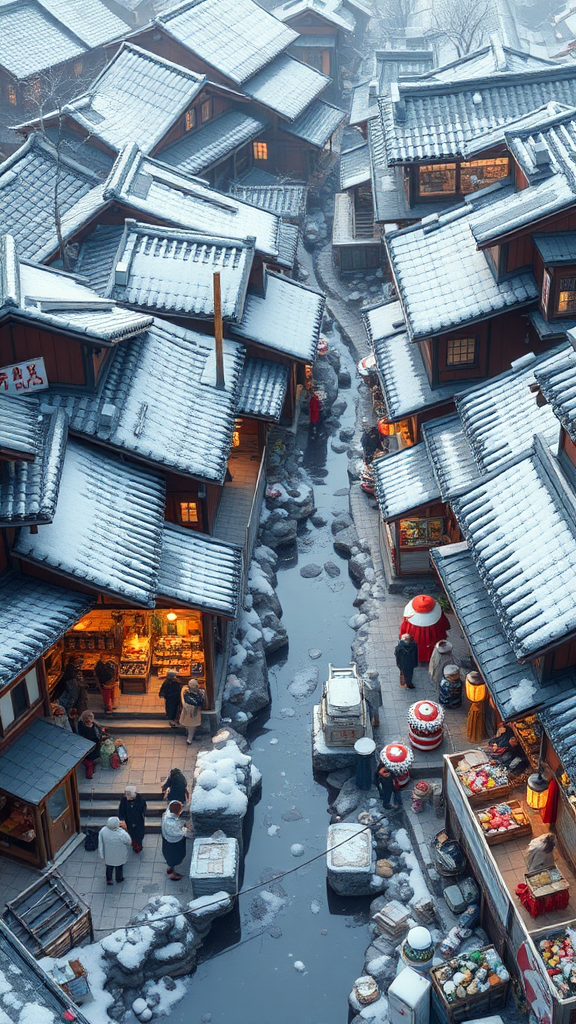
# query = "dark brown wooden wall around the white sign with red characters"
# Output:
<box><xmin>0</xmin><ymin>324</ymin><xmax>86</xmax><ymax>384</ymax></box>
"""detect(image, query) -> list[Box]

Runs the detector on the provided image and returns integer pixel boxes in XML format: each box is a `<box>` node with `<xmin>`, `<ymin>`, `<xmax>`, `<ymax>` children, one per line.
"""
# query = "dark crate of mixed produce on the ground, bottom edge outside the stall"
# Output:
<box><xmin>429</xmin><ymin>945</ymin><xmax>509</xmax><ymax>1024</ymax></box>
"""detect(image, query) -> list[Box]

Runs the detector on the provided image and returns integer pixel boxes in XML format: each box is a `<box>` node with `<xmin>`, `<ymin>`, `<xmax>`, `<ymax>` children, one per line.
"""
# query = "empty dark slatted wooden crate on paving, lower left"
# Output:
<box><xmin>4</xmin><ymin>871</ymin><xmax>94</xmax><ymax>957</ymax></box>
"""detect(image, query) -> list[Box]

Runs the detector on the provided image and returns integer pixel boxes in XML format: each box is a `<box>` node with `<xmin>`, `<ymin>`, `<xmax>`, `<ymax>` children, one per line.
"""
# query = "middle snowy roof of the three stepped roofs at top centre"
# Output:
<box><xmin>244</xmin><ymin>53</ymin><xmax>330</xmax><ymax>121</ymax></box>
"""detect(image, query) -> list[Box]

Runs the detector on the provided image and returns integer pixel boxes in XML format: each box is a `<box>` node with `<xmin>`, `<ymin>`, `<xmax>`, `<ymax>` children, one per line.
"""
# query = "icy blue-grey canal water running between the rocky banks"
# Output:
<box><xmin>170</xmin><ymin>342</ymin><xmax>369</xmax><ymax>1024</ymax></box>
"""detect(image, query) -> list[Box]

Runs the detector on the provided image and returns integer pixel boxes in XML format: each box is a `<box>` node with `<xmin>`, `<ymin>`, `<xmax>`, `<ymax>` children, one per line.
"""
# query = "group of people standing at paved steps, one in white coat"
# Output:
<box><xmin>98</xmin><ymin>768</ymin><xmax>192</xmax><ymax>886</ymax></box>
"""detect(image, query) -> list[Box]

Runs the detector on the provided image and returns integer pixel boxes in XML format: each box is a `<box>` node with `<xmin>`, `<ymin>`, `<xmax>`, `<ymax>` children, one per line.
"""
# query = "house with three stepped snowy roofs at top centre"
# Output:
<box><xmin>130</xmin><ymin>0</ymin><xmax>345</xmax><ymax>178</ymax></box>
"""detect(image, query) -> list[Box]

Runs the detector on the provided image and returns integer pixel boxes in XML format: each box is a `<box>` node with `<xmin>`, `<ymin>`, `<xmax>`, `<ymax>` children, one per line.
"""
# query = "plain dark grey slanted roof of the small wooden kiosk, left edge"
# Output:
<box><xmin>0</xmin><ymin>718</ymin><xmax>94</xmax><ymax>806</ymax></box>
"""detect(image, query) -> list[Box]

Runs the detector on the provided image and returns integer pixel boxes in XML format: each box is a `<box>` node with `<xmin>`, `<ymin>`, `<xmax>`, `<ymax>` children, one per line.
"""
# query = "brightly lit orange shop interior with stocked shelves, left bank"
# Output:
<box><xmin>45</xmin><ymin>604</ymin><xmax>211</xmax><ymax>714</ymax></box>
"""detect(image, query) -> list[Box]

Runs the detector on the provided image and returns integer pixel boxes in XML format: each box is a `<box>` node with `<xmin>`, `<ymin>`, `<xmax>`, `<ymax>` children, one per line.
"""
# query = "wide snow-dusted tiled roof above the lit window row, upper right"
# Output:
<box><xmin>380</xmin><ymin>62</ymin><xmax>576</xmax><ymax>163</ymax></box>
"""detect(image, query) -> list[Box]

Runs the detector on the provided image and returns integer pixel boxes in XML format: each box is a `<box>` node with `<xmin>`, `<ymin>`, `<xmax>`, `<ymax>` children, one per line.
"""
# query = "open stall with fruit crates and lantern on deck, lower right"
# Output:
<box><xmin>444</xmin><ymin>745</ymin><xmax>576</xmax><ymax>1024</ymax></box>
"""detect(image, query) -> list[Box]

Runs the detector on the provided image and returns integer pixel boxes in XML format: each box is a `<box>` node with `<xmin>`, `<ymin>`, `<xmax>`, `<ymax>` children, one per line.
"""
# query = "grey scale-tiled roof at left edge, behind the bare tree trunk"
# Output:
<box><xmin>0</xmin><ymin>134</ymin><xmax>98</xmax><ymax>259</ymax></box>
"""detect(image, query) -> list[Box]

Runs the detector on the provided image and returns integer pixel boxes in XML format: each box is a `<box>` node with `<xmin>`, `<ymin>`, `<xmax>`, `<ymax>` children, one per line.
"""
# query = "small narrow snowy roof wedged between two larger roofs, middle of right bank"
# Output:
<box><xmin>421</xmin><ymin>416</ymin><xmax>479</xmax><ymax>501</ymax></box>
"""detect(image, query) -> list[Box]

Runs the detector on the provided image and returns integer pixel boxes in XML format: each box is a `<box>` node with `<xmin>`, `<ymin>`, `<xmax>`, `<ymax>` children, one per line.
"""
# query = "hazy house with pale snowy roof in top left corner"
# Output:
<box><xmin>0</xmin><ymin>0</ymin><xmax>130</xmax><ymax>159</ymax></box>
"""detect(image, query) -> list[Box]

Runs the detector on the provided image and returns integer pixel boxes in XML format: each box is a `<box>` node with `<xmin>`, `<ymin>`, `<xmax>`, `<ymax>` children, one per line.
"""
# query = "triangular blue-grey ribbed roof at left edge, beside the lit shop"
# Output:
<box><xmin>0</xmin><ymin>572</ymin><xmax>94</xmax><ymax>687</ymax></box>
